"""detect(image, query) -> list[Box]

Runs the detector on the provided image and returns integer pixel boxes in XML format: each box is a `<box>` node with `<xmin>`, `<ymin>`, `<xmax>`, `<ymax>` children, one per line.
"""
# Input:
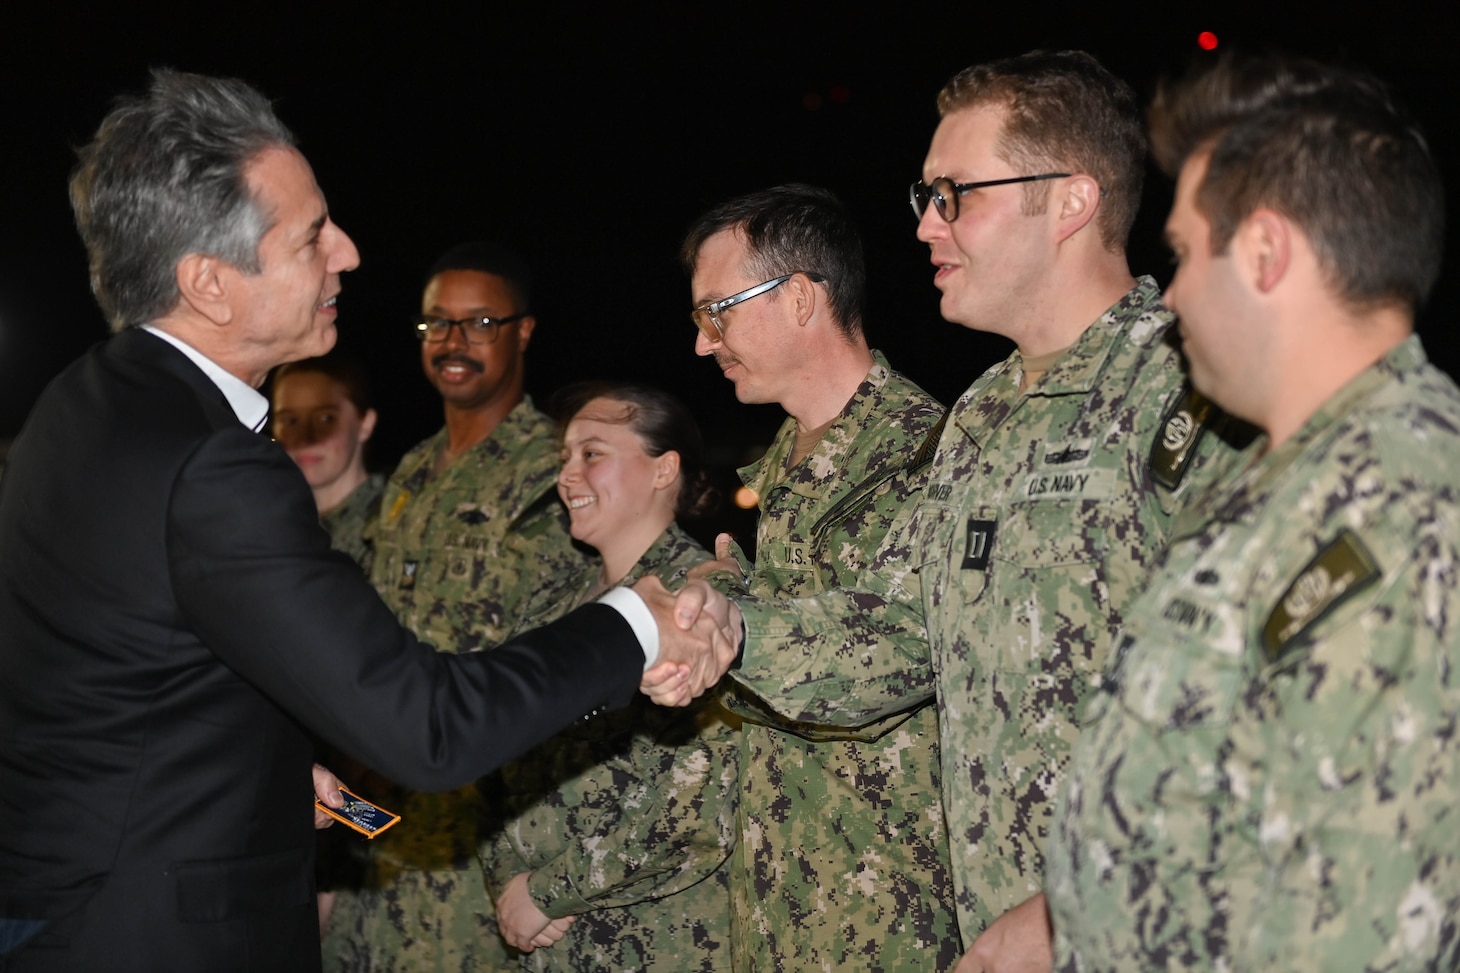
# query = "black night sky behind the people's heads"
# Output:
<box><xmin>0</xmin><ymin>0</ymin><xmax>1460</xmax><ymax>540</ymax></box>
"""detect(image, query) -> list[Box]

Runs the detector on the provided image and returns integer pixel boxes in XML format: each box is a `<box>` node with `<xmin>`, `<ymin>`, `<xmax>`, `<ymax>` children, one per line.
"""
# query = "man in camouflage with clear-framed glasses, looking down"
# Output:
<box><xmin>683</xmin><ymin>186</ymin><xmax>959</xmax><ymax>970</ymax></box>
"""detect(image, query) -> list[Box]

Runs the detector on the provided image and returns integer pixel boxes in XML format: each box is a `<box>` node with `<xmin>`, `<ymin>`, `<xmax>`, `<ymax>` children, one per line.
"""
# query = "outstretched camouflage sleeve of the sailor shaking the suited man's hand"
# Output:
<box><xmin>733</xmin><ymin>507</ymin><xmax>934</xmax><ymax>726</ymax></box>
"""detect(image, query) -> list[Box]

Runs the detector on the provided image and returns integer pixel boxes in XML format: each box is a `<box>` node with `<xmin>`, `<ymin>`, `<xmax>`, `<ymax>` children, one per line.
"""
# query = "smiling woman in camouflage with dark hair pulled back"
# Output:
<box><xmin>482</xmin><ymin>383</ymin><xmax>740</xmax><ymax>973</ymax></box>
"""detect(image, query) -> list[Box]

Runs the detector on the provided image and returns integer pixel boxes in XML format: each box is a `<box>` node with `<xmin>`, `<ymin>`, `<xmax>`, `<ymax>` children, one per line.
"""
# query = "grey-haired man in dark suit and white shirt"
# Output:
<box><xmin>0</xmin><ymin>73</ymin><xmax>727</xmax><ymax>973</ymax></box>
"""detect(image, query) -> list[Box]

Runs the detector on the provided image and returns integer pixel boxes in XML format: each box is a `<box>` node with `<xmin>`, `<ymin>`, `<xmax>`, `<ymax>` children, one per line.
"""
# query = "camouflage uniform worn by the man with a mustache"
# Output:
<box><xmin>326</xmin><ymin>399</ymin><xmax>584</xmax><ymax>972</ymax></box>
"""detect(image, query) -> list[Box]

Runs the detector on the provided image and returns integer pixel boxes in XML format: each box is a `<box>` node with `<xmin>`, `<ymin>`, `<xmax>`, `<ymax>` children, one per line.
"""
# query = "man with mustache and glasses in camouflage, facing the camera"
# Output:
<box><xmin>326</xmin><ymin>243</ymin><xmax>583</xmax><ymax>970</ymax></box>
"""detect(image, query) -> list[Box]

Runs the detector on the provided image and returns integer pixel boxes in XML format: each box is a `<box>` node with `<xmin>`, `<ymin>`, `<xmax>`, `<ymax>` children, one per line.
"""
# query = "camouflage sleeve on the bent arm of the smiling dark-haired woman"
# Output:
<box><xmin>516</xmin><ymin>703</ymin><xmax>739</xmax><ymax>917</ymax></box>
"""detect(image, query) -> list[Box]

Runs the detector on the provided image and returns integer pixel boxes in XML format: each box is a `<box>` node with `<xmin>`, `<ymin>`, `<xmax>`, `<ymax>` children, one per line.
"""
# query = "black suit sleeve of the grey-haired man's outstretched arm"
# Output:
<box><xmin>166</xmin><ymin>430</ymin><xmax>644</xmax><ymax>790</ymax></box>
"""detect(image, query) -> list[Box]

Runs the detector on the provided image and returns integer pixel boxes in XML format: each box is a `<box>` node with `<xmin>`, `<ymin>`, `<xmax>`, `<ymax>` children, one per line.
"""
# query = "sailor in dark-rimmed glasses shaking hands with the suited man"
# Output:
<box><xmin>664</xmin><ymin>51</ymin><xmax>1238</xmax><ymax>970</ymax></box>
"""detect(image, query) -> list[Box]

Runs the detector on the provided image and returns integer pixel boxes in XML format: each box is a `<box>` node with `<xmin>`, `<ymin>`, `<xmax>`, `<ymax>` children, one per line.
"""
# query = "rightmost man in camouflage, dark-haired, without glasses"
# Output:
<box><xmin>1048</xmin><ymin>58</ymin><xmax>1460</xmax><ymax>970</ymax></box>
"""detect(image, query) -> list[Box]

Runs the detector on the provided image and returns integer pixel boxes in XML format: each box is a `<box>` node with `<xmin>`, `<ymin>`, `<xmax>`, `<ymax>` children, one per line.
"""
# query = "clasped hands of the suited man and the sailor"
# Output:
<box><xmin>634</xmin><ymin>577</ymin><xmax>740</xmax><ymax>706</ymax></box>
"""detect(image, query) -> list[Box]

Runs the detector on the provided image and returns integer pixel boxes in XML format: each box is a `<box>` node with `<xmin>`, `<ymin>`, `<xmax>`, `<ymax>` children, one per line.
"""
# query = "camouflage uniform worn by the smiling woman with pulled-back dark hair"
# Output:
<box><xmin>482</xmin><ymin>524</ymin><xmax>739</xmax><ymax>973</ymax></box>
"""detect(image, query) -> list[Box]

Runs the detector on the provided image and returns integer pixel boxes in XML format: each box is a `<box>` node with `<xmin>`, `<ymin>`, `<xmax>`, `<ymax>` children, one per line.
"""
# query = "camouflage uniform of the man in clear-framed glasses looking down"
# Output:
<box><xmin>718</xmin><ymin>354</ymin><xmax>959</xmax><ymax>970</ymax></box>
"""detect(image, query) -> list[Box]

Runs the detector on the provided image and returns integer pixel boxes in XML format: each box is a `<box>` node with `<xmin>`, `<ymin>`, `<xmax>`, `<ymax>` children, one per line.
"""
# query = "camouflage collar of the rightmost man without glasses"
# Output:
<box><xmin>1174</xmin><ymin>335</ymin><xmax>1429</xmax><ymax>536</ymax></box>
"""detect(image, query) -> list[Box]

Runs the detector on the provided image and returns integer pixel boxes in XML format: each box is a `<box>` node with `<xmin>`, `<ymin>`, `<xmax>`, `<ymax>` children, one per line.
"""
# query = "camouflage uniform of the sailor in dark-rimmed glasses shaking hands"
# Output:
<box><xmin>740</xmin><ymin>278</ymin><xmax>1216</xmax><ymax>945</ymax></box>
